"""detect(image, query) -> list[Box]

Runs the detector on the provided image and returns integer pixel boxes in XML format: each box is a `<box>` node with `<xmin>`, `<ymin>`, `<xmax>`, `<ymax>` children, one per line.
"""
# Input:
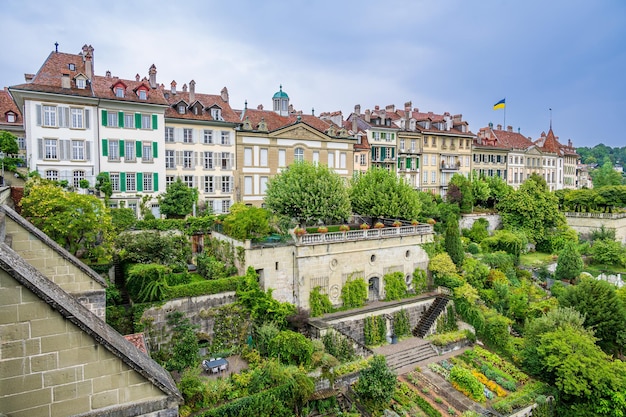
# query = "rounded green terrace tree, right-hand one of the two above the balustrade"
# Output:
<box><xmin>350</xmin><ymin>168</ymin><xmax>421</xmax><ymax>220</ymax></box>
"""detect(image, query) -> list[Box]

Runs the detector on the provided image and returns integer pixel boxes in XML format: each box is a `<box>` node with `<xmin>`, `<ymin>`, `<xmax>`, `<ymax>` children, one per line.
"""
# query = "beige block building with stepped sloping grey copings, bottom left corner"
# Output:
<box><xmin>0</xmin><ymin>200</ymin><xmax>182</xmax><ymax>417</ymax></box>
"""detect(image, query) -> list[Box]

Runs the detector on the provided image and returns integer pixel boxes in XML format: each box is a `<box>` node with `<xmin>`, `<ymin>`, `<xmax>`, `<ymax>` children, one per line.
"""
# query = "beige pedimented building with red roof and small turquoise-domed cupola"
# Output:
<box><xmin>235</xmin><ymin>87</ymin><xmax>356</xmax><ymax>206</ymax></box>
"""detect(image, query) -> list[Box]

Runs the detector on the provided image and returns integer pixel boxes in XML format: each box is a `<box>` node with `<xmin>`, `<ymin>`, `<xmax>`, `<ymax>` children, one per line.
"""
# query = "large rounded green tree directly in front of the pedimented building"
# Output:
<box><xmin>265</xmin><ymin>161</ymin><xmax>351</xmax><ymax>225</ymax></box>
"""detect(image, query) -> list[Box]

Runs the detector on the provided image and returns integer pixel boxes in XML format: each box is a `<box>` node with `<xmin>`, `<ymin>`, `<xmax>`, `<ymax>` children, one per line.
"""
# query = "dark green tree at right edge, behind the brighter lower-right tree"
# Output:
<box><xmin>559</xmin><ymin>278</ymin><xmax>626</xmax><ymax>354</ymax></box>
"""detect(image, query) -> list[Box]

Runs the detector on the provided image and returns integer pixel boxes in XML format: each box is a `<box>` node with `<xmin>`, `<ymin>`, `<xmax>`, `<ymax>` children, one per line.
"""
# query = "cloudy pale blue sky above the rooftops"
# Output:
<box><xmin>0</xmin><ymin>0</ymin><xmax>626</xmax><ymax>146</ymax></box>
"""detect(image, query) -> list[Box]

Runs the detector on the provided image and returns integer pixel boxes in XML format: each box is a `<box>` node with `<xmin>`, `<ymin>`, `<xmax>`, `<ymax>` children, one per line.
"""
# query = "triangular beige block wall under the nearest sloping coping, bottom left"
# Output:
<box><xmin>0</xmin><ymin>270</ymin><xmax>177</xmax><ymax>417</ymax></box>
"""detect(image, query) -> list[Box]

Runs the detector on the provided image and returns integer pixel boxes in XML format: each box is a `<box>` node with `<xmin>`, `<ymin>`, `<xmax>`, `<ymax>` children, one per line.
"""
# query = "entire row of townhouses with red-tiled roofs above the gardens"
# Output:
<box><xmin>0</xmin><ymin>45</ymin><xmax>579</xmax><ymax>215</ymax></box>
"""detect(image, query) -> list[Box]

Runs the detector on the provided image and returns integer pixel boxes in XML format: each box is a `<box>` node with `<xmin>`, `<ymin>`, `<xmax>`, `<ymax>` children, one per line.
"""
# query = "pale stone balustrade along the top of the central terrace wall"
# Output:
<box><xmin>297</xmin><ymin>224</ymin><xmax>433</xmax><ymax>245</ymax></box>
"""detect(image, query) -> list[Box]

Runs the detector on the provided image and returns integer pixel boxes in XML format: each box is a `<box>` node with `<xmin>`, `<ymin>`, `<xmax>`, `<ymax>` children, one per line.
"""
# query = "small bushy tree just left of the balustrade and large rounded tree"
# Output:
<box><xmin>223</xmin><ymin>203</ymin><xmax>270</xmax><ymax>240</ymax></box>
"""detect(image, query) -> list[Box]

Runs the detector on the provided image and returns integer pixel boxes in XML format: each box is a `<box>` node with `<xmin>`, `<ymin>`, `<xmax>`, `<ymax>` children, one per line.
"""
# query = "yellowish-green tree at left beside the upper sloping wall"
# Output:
<box><xmin>20</xmin><ymin>178</ymin><xmax>113</xmax><ymax>258</ymax></box>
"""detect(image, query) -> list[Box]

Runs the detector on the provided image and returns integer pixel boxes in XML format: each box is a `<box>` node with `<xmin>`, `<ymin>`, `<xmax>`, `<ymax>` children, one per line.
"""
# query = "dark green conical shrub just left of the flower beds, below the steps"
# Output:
<box><xmin>354</xmin><ymin>355</ymin><xmax>397</xmax><ymax>409</ymax></box>
